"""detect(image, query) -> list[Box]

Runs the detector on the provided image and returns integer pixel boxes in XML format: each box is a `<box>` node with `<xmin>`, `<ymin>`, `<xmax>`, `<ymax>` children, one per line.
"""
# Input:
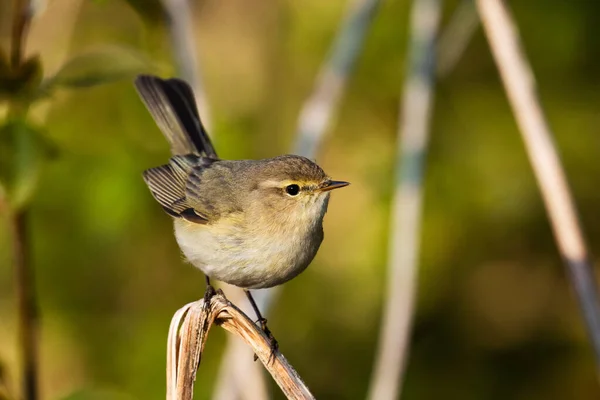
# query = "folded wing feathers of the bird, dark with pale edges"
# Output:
<box><xmin>143</xmin><ymin>155</ymin><xmax>214</xmax><ymax>224</ymax></box>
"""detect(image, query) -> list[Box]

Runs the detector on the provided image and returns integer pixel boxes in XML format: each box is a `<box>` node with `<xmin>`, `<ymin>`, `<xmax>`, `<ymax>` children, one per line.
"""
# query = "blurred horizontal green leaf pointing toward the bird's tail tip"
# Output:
<box><xmin>40</xmin><ymin>46</ymin><xmax>153</xmax><ymax>96</ymax></box>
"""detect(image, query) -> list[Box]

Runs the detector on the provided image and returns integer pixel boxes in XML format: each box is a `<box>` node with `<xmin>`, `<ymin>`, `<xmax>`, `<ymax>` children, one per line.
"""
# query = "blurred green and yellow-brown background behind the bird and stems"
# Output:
<box><xmin>0</xmin><ymin>0</ymin><xmax>600</xmax><ymax>399</ymax></box>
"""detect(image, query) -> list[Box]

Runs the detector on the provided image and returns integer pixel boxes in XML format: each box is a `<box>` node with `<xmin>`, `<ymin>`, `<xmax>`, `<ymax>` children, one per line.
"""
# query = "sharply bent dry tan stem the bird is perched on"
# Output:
<box><xmin>167</xmin><ymin>293</ymin><xmax>314</xmax><ymax>400</ymax></box>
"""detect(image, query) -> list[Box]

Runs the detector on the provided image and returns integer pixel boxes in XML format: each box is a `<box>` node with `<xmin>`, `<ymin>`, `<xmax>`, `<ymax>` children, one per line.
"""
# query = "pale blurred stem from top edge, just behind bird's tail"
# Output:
<box><xmin>161</xmin><ymin>0</ymin><xmax>211</xmax><ymax>130</ymax></box>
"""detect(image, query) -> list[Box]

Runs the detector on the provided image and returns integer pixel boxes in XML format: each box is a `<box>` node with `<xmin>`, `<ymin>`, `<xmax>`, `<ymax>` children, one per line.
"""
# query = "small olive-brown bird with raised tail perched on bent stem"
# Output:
<box><xmin>134</xmin><ymin>75</ymin><xmax>349</xmax><ymax>349</ymax></box>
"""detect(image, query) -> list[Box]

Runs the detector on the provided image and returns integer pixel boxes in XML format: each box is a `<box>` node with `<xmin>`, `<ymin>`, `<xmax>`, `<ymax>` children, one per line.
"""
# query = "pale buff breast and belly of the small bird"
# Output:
<box><xmin>175</xmin><ymin>208</ymin><xmax>323</xmax><ymax>289</ymax></box>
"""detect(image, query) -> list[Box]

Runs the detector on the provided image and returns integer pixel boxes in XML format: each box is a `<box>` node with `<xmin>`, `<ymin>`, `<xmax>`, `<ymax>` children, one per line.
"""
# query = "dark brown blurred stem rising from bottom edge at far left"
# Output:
<box><xmin>9</xmin><ymin>210</ymin><xmax>38</xmax><ymax>400</ymax></box>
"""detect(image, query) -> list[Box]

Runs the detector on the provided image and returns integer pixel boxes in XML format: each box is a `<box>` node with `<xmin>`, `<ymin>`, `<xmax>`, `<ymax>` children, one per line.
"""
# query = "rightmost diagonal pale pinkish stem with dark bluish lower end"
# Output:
<box><xmin>476</xmin><ymin>0</ymin><xmax>600</xmax><ymax>378</ymax></box>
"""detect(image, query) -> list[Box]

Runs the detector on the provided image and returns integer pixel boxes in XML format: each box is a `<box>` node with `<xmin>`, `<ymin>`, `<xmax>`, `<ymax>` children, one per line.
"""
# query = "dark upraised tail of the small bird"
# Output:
<box><xmin>135</xmin><ymin>75</ymin><xmax>217</xmax><ymax>159</ymax></box>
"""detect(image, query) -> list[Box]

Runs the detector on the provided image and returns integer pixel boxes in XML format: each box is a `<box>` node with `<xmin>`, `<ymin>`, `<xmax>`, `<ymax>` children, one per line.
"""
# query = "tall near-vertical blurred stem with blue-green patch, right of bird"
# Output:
<box><xmin>368</xmin><ymin>0</ymin><xmax>441</xmax><ymax>400</ymax></box>
